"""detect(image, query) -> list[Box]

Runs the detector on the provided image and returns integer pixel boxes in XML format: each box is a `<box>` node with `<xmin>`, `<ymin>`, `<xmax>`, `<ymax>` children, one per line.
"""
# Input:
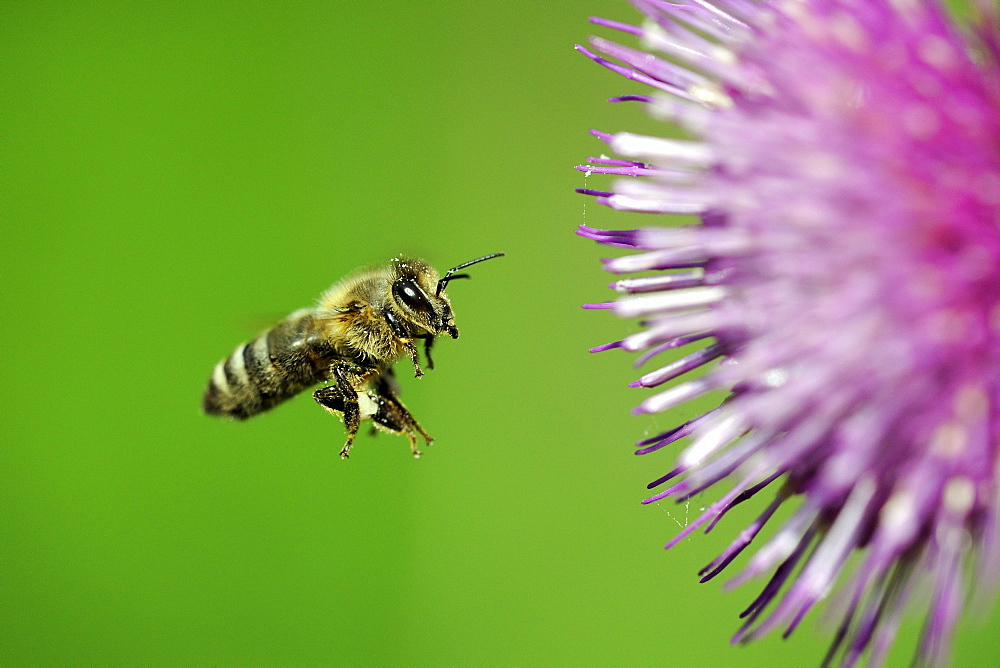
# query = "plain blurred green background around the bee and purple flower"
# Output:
<box><xmin>0</xmin><ymin>0</ymin><xmax>1000</xmax><ymax>666</ymax></box>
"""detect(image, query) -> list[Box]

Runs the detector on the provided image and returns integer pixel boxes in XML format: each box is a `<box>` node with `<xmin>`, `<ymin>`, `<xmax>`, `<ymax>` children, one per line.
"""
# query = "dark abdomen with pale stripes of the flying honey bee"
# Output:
<box><xmin>202</xmin><ymin>309</ymin><xmax>334</xmax><ymax>420</ymax></box>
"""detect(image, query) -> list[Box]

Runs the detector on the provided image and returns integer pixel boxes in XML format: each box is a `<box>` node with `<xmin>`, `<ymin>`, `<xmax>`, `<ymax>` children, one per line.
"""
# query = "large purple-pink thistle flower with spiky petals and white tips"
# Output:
<box><xmin>578</xmin><ymin>0</ymin><xmax>1000</xmax><ymax>665</ymax></box>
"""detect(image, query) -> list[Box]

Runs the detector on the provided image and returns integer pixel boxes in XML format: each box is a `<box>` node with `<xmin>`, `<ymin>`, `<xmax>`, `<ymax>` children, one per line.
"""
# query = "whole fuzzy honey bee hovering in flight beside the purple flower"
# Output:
<box><xmin>202</xmin><ymin>253</ymin><xmax>503</xmax><ymax>459</ymax></box>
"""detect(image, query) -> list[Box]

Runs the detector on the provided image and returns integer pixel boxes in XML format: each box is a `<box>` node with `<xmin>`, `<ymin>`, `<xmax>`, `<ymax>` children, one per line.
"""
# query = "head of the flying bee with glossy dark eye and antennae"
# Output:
<box><xmin>387</xmin><ymin>253</ymin><xmax>503</xmax><ymax>339</ymax></box>
